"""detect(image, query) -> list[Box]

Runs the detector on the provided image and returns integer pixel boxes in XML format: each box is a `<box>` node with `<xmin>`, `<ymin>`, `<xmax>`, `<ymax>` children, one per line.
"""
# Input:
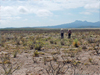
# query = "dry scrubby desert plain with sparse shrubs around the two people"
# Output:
<box><xmin>0</xmin><ymin>29</ymin><xmax>100</xmax><ymax>75</ymax></box>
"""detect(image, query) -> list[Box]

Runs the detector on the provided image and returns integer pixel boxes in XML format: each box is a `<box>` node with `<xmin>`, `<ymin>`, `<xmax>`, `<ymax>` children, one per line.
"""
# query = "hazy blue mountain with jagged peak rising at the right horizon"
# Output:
<box><xmin>40</xmin><ymin>20</ymin><xmax>100</xmax><ymax>28</ymax></box>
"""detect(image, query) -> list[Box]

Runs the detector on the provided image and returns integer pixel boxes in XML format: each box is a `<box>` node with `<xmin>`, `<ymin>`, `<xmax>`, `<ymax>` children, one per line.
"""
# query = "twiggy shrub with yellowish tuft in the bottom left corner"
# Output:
<box><xmin>0</xmin><ymin>54</ymin><xmax>19</xmax><ymax>75</ymax></box>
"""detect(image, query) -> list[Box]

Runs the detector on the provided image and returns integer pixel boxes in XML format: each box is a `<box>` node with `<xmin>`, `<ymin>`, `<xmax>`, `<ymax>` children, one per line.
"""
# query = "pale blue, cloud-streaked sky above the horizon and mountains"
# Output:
<box><xmin>0</xmin><ymin>0</ymin><xmax>100</xmax><ymax>28</ymax></box>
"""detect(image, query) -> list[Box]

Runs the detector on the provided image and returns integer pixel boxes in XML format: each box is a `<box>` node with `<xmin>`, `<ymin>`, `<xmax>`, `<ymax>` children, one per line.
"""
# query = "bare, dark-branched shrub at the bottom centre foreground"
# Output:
<box><xmin>43</xmin><ymin>56</ymin><xmax>70</xmax><ymax>75</ymax></box>
